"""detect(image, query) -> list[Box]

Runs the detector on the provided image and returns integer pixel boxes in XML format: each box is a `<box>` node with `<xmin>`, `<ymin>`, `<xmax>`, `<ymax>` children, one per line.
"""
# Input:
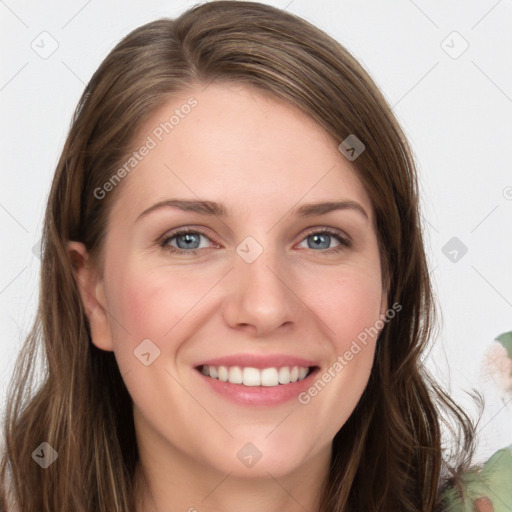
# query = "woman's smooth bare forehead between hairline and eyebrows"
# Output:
<box><xmin>109</xmin><ymin>83</ymin><xmax>372</xmax><ymax>222</ymax></box>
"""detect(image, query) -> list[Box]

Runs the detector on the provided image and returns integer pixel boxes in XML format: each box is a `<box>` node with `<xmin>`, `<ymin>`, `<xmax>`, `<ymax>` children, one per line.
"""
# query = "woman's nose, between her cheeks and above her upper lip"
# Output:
<box><xmin>223</xmin><ymin>243</ymin><xmax>304</xmax><ymax>337</ymax></box>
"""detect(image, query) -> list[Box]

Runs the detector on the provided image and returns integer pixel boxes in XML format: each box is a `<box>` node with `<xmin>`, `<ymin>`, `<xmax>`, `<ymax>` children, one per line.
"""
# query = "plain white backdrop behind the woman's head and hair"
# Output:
<box><xmin>0</xmin><ymin>0</ymin><xmax>512</xmax><ymax>459</ymax></box>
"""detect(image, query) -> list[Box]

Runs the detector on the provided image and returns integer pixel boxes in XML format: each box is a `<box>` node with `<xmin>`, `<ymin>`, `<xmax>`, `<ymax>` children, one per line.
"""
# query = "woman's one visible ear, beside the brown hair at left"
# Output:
<box><xmin>67</xmin><ymin>241</ymin><xmax>113</xmax><ymax>350</ymax></box>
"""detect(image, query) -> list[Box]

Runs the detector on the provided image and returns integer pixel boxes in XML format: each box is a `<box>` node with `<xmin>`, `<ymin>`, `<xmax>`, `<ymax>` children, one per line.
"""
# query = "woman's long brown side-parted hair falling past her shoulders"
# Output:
<box><xmin>0</xmin><ymin>1</ymin><xmax>474</xmax><ymax>512</ymax></box>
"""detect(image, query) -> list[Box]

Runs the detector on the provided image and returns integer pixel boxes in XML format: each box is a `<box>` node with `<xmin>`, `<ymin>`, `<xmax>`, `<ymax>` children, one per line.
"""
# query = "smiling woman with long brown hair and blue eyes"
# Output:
<box><xmin>1</xmin><ymin>1</ymin><xmax>510</xmax><ymax>512</ymax></box>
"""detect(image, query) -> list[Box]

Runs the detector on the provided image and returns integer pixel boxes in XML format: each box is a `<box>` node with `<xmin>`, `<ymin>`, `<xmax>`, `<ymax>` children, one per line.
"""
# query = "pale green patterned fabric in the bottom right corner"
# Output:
<box><xmin>442</xmin><ymin>445</ymin><xmax>512</xmax><ymax>512</ymax></box>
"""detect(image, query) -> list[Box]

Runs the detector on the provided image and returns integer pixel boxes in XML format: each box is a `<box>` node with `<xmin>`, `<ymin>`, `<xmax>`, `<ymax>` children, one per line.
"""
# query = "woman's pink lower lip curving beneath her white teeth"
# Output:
<box><xmin>196</xmin><ymin>368</ymin><xmax>319</xmax><ymax>406</ymax></box>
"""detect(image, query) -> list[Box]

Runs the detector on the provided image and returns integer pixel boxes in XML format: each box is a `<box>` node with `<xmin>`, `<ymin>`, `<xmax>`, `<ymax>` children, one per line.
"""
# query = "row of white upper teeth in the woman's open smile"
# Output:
<box><xmin>201</xmin><ymin>365</ymin><xmax>309</xmax><ymax>387</ymax></box>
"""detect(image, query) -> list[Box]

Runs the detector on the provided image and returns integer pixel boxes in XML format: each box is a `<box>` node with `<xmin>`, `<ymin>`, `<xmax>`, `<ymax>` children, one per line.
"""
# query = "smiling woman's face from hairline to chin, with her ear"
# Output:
<box><xmin>73</xmin><ymin>84</ymin><xmax>387</xmax><ymax>477</ymax></box>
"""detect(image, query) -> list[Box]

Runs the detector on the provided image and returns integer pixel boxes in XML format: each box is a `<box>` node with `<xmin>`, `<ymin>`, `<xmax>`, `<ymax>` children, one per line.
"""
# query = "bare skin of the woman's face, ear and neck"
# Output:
<box><xmin>68</xmin><ymin>83</ymin><xmax>388</xmax><ymax>512</ymax></box>
